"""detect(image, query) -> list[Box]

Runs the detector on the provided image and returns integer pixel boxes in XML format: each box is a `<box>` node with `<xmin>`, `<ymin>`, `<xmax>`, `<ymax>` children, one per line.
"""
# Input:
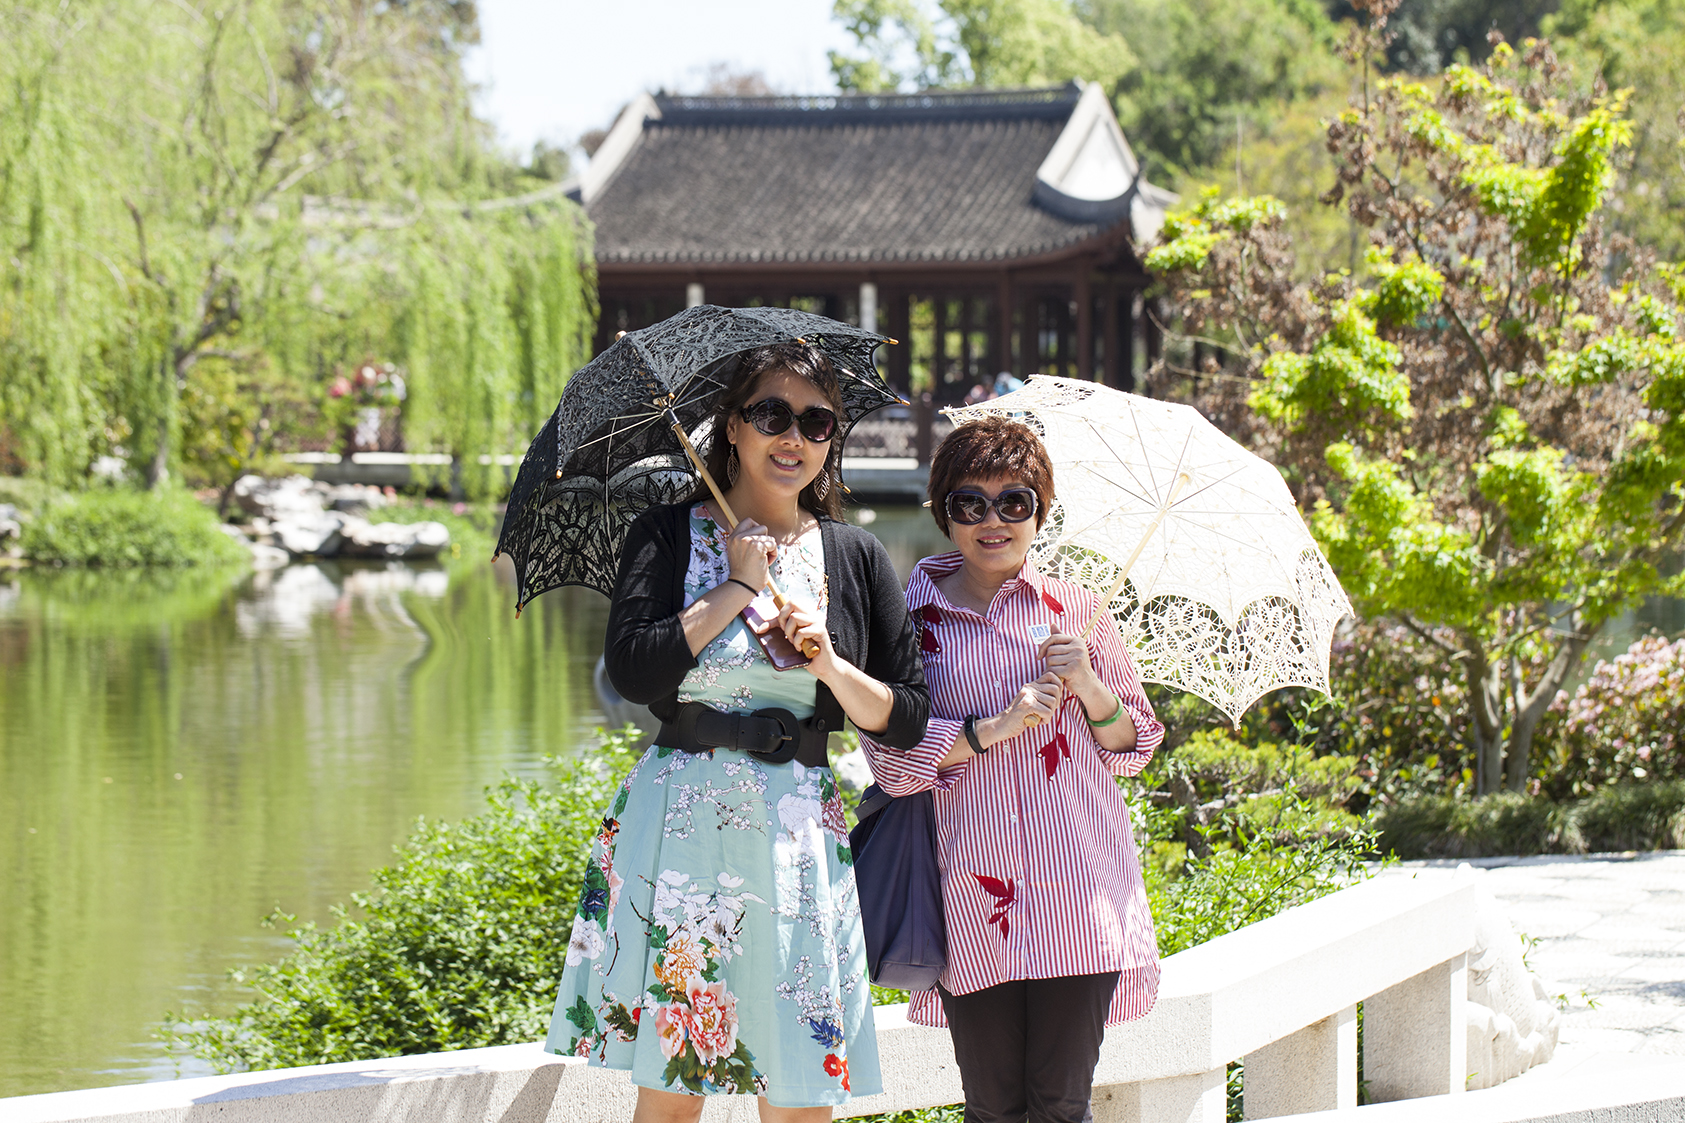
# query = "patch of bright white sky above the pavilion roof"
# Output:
<box><xmin>468</xmin><ymin>0</ymin><xmax>853</xmax><ymax>167</ymax></box>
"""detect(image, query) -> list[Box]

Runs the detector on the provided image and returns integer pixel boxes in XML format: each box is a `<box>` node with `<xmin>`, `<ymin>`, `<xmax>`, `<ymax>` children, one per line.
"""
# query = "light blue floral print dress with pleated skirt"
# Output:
<box><xmin>544</xmin><ymin>506</ymin><xmax>881</xmax><ymax>1108</ymax></box>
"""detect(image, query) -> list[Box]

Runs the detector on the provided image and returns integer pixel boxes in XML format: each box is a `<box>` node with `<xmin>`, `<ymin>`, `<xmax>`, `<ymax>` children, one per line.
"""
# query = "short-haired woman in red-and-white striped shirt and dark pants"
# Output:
<box><xmin>864</xmin><ymin>418</ymin><xmax>1164</xmax><ymax>1123</ymax></box>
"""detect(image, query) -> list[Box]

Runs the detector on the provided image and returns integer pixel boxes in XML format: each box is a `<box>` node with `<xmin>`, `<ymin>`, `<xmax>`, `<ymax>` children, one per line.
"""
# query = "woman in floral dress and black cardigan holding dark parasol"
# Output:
<box><xmin>546</xmin><ymin>337</ymin><xmax>928</xmax><ymax>1123</ymax></box>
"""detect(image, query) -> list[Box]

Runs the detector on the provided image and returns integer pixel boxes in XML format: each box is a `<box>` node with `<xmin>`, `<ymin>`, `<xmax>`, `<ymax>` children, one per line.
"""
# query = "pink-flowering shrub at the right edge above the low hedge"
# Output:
<box><xmin>1537</xmin><ymin>636</ymin><xmax>1685</xmax><ymax>799</ymax></box>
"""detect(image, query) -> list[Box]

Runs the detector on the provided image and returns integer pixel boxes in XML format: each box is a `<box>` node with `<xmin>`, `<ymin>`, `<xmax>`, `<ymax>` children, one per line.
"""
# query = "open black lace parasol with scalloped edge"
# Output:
<box><xmin>497</xmin><ymin>304</ymin><xmax>898</xmax><ymax>612</ymax></box>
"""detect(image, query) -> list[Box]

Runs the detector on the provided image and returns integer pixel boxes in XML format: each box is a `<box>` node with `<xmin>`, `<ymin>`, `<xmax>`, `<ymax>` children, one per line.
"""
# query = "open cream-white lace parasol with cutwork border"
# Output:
<box><xmin>947</xmin><ymin>374</ymin><xmax>1351</xmax><ymax>723</ymax></box>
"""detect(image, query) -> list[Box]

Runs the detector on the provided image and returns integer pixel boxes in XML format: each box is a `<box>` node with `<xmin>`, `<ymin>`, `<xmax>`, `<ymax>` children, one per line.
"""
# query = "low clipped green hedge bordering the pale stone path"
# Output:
<box><xmin>1372</xmin><ymin>781</ymin><xmax>1685</xmax><ymax>858</ymax></box>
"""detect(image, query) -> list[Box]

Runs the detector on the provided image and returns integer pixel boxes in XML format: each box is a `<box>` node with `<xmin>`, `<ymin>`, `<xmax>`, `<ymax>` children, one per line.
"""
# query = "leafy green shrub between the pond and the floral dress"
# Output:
<box><xmin>165</xmin><ymin>727</ymin><xmax>635</xmax><ymax>1072</ymax></box>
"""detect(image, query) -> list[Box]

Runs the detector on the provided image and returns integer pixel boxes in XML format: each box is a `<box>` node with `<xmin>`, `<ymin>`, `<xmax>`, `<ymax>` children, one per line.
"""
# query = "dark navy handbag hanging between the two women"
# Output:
<box><xmin>848</xmin><ymin>784</ymin><xmax>947</xmax><ymax>990</ymax></box>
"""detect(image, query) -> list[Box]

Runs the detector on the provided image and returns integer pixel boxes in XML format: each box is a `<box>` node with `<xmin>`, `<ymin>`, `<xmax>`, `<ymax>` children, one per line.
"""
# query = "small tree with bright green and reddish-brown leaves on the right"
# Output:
<box><xmin>1147</xmin><ymin>21</ymin><xmax>1685</xmax><ymax>791</ymax></box>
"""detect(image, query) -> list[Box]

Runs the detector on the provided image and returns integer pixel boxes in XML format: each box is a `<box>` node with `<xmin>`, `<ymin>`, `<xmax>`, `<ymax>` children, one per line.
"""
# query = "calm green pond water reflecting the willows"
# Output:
<box><xmin>0</xmin><ymin>509</ymin><xmax>945</xmax><ymax>1096</ymax></box>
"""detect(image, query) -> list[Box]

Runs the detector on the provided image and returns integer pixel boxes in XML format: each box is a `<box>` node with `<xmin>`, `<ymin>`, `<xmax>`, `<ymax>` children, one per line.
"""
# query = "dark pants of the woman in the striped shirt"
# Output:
<box><xmin>942</xmin><ymin>971</ymin><xmax>1117</xmax><ymax>1123</ymax></box>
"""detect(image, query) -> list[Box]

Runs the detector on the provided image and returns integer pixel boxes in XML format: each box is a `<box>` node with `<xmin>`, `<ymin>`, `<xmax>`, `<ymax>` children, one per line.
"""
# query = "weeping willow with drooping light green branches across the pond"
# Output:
<box><xmin>0</xmin><ymin>0</ymin><xmax>596</xmax><ymax>487</ymax></box>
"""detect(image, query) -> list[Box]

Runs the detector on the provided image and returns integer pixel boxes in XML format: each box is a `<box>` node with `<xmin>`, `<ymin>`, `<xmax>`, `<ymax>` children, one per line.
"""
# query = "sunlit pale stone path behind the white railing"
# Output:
<box><xmin>1405</xmin><ymin>850</ymin><xmax>1685</xmax><ymax>1067</ymax></box>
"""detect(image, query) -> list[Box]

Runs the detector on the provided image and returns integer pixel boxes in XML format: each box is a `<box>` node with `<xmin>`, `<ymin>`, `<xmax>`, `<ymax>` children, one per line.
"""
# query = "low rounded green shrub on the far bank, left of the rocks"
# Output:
<box><xmin>22</xmin><ymin>487</ymin><xmax>249</xmax><ymax>567</ymax></box>
